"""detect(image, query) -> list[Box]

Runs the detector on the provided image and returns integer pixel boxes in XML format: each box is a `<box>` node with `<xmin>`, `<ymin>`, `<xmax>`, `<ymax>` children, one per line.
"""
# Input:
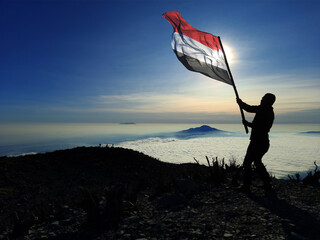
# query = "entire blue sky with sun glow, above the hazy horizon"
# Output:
<box><xmin>0</xmin><ymin>0</ymin><xmax>320</xmax><ymax>123</ymax></box>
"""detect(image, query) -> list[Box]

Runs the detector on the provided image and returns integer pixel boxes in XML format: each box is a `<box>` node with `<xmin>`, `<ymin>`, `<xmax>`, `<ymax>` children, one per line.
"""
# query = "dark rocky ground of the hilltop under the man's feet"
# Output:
<box><xmin>0</xmin><ymin>147</ymin><xmax>320</xmax><ymax>240</ymax></box>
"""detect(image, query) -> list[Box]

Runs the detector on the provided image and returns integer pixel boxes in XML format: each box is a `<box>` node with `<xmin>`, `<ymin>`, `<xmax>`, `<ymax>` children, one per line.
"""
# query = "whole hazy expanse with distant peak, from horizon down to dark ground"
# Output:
<box><xmin>0</xmin><ymin>124</ymin><xmax>320</xmax><ymax>178</ymax></box>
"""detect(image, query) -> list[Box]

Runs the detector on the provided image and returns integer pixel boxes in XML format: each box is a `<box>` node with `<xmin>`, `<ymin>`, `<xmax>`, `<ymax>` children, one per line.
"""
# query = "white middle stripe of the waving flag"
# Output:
<box><xmin>171</xmin><ymin>32</ymin><xmax>228</xmax><ymax>71</ymax></box>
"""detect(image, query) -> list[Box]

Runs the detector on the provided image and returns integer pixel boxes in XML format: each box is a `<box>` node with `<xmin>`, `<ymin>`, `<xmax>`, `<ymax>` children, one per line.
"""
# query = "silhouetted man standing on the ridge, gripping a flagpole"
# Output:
<box><xmin>237</xmin><ymin>93</ymin><xmax>276</xmax><ymax>192</ymax></box>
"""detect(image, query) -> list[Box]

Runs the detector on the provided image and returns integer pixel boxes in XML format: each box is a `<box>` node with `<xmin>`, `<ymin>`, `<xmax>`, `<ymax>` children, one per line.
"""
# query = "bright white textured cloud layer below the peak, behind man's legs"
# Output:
<box><xmin>117</xmin><ymin>134</ymin><xmax>320</xmax><ymax>178</ymax></box>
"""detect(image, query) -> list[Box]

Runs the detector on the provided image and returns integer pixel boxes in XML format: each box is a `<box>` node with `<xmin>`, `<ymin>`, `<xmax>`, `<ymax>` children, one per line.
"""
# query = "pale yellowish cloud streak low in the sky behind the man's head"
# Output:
<box><xmin>90</xmin><ymin>74</ymin><xmax>320</xmax><ymax>121</ymax></box>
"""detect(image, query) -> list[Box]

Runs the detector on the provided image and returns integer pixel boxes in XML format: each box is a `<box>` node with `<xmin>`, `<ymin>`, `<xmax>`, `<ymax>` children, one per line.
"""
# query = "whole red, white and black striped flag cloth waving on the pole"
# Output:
<box><xmin>162</xmin><ymin>11</ymin><xmax>233</xmax><ymax>85</ymax></box>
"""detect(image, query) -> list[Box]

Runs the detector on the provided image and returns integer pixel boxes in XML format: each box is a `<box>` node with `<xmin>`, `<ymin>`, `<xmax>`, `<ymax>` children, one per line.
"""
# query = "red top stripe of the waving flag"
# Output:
<box><xmin>162</xmin><ymin>11</ymin><xmax>221</xmax><ymax>51</ymax></box>
